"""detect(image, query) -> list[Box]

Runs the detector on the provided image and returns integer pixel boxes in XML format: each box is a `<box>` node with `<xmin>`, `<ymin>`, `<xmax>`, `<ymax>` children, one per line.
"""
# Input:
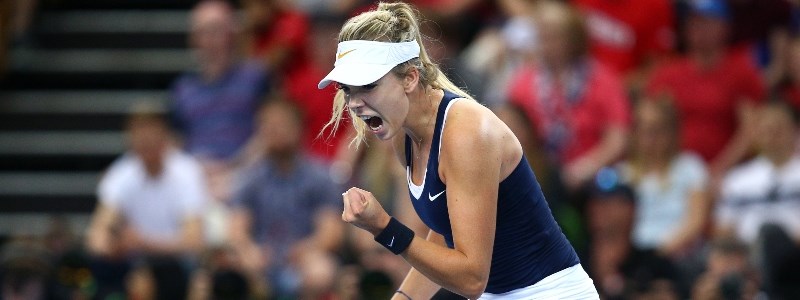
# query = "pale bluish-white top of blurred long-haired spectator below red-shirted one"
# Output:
<box><xmin>621</xmin><ymin>152</ymin><xmax>708</xmax><ymax>249</ymax></box>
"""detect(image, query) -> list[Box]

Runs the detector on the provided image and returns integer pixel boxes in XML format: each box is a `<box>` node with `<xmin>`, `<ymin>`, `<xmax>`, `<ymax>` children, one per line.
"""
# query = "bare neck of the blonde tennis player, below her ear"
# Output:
<box><xmin>404</xmin><ymin>88</ymin><xmax>444</xmax><ymax>148</ymax></box>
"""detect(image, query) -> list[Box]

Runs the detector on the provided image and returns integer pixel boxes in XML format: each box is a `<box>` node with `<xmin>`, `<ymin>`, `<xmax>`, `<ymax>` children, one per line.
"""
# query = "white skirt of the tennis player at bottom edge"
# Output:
<box><xmin>478</xmin><ymin>264</ymin><xmax>600</xmax><ymax>300</ymax></box>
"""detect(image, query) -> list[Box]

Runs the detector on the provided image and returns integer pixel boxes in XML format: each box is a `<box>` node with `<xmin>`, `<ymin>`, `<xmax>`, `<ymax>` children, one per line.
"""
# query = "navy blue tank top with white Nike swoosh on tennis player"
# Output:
<box><xmin>405</xmin><ymin>91</ymin><xmax>579</xmax><ymax>294</ymax></box>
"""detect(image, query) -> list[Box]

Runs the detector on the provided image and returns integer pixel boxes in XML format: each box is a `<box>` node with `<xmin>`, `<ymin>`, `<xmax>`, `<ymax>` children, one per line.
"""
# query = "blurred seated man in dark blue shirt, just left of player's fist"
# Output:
<box><xmin>230</xmin><ymin>98</ymin><xmax>343</xmax><ymax>299</ymax></box>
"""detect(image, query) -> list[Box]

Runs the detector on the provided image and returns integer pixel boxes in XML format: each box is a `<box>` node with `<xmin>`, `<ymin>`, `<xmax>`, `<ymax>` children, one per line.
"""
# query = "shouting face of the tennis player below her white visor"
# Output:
<box><xmin>338</xmin><ymin>72</ymin><xmax>410</xmax><ymax>140</ymax></box>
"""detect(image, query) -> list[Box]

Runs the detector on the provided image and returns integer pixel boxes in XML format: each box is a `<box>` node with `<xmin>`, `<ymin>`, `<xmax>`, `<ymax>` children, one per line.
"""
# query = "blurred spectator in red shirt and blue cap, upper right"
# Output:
<box><xmin>647</xmin><ymin>0</ymin><xmax>765</xmax><ymax>188</ymax></box>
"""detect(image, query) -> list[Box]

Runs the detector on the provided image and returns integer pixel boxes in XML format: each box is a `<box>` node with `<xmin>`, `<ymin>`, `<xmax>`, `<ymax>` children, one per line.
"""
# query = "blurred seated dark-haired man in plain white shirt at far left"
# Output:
<box><xmin>86</xmin><ymin>104</ymin><xmax>209</xmax><ymax>299</ymax></box>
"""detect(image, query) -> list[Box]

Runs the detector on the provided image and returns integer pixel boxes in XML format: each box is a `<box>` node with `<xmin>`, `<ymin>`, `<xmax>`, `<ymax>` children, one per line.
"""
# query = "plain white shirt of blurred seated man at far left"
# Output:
<box><xmin>97</xmin><ymin>150</ymin><xmax>209</xmax><ymax>241</ymax></box>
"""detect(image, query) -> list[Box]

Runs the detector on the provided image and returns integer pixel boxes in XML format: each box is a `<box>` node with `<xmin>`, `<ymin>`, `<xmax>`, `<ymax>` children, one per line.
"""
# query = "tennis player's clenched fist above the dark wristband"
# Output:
<box><xmin>342</xmin><ymin>187</ymin><xmax>391</xmax><ymax>235</ymax></box>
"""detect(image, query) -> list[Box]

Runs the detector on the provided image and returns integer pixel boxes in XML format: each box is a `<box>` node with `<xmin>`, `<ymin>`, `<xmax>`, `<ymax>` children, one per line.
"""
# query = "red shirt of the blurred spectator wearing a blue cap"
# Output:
<box><xmin>647</xmin><ymin>51</ymin><xmax>766</xmax><ymax>162</ymax></box>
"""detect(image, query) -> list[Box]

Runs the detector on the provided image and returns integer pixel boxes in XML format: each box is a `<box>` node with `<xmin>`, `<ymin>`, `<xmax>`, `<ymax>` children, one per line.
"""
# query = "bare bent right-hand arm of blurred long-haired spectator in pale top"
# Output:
<box><xmin>659</xmin><ymin>190</ymin><xmax>710</xmax><ymax>257</ymax></box>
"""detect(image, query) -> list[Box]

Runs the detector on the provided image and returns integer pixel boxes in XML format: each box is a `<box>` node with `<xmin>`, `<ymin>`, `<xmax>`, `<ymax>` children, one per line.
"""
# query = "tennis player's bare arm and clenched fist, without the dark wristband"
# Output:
<box><xmin>342</xmin><ymin>101</ymin><xmax>521</xmax><ymax>299</ymax></box>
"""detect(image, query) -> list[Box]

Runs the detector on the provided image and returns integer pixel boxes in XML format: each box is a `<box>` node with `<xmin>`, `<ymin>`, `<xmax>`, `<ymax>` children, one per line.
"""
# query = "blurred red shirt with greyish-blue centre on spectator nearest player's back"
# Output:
<box><xmin>509</xmin><ymin>62</ymin><xmax>630</xmax><ymax>163</ymax></box>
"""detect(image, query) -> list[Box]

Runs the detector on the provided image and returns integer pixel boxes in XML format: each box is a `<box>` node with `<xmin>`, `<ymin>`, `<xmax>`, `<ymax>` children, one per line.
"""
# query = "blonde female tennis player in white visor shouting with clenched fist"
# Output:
<box><xmin>319</xmin><ymin>3</ymin><xmax>599</xmax><ymax>300</ymax></box>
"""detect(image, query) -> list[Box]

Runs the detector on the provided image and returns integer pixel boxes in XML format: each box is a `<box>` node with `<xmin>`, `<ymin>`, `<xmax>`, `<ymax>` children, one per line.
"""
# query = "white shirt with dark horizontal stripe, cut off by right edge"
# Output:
<box><xmin>716</xmin><ymin>155</ymin><xmax>800</xmax><ymax>243</ymax></box>
